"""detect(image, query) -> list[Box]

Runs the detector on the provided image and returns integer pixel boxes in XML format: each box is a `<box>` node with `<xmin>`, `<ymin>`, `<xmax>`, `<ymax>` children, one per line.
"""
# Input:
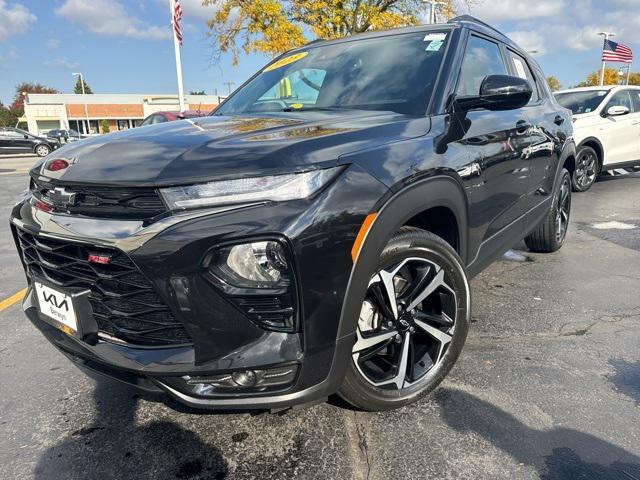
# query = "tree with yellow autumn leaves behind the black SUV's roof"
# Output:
<box><xmin>202</xmin><ymin>0</ymin><xmax>455</xmax><ymax>63</ymax></box>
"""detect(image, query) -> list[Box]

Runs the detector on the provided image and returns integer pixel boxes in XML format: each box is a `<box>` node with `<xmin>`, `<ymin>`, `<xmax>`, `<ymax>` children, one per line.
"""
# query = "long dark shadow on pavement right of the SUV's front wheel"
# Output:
<box><xmin>433</xmin><ymin>388</ymin><xmax>640</xmax><ymax>480</ymax></box>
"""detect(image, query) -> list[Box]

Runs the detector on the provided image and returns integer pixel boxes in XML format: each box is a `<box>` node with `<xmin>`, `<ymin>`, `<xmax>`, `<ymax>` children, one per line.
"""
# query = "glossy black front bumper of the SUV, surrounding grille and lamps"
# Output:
<box><xmin>11</xmin><ymin>166</ymin><xmax>387</xmax><ymax>409</ymax></box>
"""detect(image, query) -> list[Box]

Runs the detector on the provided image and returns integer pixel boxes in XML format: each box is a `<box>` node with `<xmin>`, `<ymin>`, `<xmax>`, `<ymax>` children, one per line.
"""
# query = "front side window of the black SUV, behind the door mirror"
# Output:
<box><xmin>457</xmin><ymin>35</ymin><xmax>507</xmax><ymax>95</ymax></box>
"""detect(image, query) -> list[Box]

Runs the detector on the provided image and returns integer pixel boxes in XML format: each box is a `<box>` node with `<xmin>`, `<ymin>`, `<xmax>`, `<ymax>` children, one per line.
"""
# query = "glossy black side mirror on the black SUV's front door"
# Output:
<box><xmin>455</xmin><ymin>75</ymin><xmax>533</xmax><ymax>111</ymax></box>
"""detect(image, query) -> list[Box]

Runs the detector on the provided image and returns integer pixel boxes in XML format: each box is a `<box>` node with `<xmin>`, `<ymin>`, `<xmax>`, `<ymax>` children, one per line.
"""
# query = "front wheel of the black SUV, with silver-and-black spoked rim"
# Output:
<box><xmin>338</xmin><ymin>229</ymin><xmax>470</xmax><ymax>411</ymax></box>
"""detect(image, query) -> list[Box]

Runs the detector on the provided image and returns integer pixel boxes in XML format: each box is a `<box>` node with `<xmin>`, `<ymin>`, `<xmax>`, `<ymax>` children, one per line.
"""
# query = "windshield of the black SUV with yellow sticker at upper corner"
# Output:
<box><xmin>215</xmin><ymin>32</ymin><xmax>447</xmax><ymax>115</ymax></box>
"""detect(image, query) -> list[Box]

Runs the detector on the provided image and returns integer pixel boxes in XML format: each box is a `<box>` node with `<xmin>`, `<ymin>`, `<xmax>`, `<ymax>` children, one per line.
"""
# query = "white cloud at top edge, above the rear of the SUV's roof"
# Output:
<box><xmin>470</xmin><ymin>0</ymin><xmax>565</xmax><ymax>22</ymax></box>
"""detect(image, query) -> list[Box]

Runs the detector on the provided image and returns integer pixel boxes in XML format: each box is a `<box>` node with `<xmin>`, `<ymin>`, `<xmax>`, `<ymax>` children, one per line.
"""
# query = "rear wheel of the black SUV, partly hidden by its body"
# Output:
<box><xmin>524</xmin><ymin>168</ymin><xmax>571</xmax><ymax>253</ymax></box>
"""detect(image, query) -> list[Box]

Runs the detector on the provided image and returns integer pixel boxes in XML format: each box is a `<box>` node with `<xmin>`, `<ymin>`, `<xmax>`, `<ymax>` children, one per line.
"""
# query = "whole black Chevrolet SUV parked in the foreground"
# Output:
<box><xmin>11</xmin><ymin>17</ymin><xmax>575</xmax><ymax>410</ymax></box>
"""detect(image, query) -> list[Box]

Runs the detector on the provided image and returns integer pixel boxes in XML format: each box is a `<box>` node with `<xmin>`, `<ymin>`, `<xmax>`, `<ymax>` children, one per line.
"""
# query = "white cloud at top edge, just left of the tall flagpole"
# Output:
<box><xmin>56</xmin><ymin>0</ymin><xmax>171</xmax><ymax>40</ymax></box>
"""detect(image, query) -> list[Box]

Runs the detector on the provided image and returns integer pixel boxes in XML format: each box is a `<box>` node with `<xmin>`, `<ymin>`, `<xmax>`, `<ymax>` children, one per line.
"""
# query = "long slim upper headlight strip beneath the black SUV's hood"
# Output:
<box><xmin>160</xmin><ymin>167</ymin><xmax>342</xmax><ymax>210</ymax></box>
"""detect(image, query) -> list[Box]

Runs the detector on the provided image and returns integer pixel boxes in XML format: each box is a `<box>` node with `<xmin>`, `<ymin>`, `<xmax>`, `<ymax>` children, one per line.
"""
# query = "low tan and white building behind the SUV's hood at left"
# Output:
<box><xmin>20</xmin><ymin>93</ymin><xmax>221</xmax><ymax>135</ymax></box>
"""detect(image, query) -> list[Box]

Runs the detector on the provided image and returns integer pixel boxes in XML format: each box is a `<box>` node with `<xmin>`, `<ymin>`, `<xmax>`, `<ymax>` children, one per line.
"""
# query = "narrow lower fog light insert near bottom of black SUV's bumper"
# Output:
<box><xmin>182</xmin><ymin>365</ymin><xmax>298</xmax><ymax>396</ymax></box>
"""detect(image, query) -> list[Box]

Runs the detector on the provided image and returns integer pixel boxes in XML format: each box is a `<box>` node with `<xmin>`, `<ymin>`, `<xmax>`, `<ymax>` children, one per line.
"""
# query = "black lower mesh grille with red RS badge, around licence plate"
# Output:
<box><xmin>18</xmin><ymin>230</ymin><xmax>191</xmax><ymax>345</ymax></box>
